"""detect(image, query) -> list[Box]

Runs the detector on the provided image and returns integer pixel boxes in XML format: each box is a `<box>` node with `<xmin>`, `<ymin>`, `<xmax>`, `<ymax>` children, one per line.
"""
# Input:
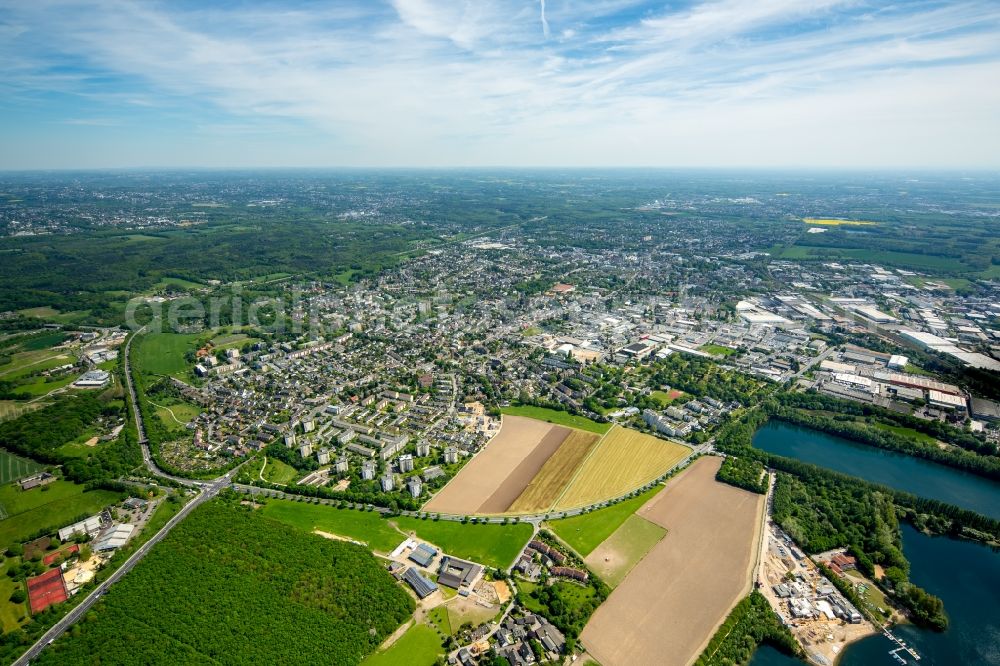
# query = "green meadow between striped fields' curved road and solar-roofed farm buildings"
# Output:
<box><xmin>393</xmin><ymin>516</ymin><xmax>531</xmax><ymax>569</ymax></box>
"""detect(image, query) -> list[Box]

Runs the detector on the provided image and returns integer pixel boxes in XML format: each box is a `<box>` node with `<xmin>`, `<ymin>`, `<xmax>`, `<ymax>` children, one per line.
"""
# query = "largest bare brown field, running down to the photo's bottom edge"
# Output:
<box><xmin>580</xmin><ymin>457</ymin><xmax>764</xmax><ymax>666</ymax></box>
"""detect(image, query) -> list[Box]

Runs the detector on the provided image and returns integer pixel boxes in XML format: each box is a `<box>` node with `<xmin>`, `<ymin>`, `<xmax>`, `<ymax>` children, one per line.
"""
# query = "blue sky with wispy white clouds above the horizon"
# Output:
<box><xmin>0</xmin><ymin>0</ymin><xmax>1000</xmax><ymax>169</ymax></box>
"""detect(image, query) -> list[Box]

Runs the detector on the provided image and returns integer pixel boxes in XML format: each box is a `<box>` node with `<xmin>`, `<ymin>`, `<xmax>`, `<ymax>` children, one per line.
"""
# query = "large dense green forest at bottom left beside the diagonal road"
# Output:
<box><xmin>38</xmin><ymin>499</ymin><xmax>415</xmax><ymax>665</ymax></box>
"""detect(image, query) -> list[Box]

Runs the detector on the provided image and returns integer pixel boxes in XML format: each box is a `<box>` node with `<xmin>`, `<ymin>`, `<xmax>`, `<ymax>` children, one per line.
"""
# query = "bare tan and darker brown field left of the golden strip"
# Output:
<box><xmin>423</xmin><ymin>416</ymin><xmax>572</xmax><ymax>515</ymax></box>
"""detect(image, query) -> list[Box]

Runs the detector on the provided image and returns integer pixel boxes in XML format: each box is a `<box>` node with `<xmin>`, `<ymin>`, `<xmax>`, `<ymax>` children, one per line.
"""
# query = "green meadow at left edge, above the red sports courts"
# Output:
<box><xmin>0</xmin><ymin>481</ymin><xmax>119</xmax><ymax>547</ymax></box>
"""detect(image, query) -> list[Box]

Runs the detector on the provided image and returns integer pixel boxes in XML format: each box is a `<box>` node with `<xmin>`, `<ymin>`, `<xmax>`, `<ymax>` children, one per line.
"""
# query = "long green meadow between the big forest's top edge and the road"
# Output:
<box><xmin>260</xmin><ymin>499</ymin><xmax>404</xmax><ymax>553</ymax></box>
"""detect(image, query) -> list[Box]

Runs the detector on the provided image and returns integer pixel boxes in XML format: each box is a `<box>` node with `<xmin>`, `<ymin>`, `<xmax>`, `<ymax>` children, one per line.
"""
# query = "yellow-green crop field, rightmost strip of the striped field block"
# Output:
<box><xmin>553</xmin><ymin>426</ymin><xmax>691</xmax><ymax>510</ymax></box>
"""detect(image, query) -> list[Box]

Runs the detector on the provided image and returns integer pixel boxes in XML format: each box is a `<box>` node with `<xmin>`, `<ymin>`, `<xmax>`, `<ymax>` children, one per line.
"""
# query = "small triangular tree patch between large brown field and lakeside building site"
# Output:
<box><xmin>695</xmin><ymin>590</ymin><xmax>802</xmax><ymax>666</ymax></box>
